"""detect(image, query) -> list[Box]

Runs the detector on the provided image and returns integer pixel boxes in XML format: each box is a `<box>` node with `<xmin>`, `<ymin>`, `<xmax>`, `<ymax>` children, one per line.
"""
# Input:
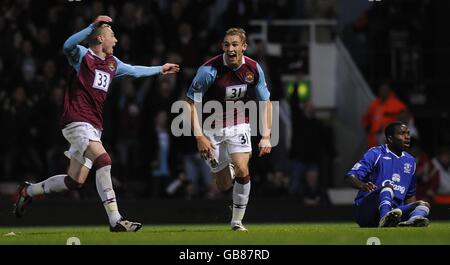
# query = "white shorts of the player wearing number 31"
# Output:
<box><xmin>204</xmin><ymin>123</ymin><xmax>252</xmax><ymax>173</ymax></box>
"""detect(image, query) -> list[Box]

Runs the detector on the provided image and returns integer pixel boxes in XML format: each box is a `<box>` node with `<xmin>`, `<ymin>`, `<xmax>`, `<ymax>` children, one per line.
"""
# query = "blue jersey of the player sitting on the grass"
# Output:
<box><xmin>347</xmin><ymin>145</ymin><xmax>416</xmax><ymax>206</ymax></box>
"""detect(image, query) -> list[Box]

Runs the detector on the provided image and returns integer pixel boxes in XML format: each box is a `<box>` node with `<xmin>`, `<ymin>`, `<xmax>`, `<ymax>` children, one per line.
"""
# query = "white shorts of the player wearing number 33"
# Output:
<box><xmin>62</xmin><ymin>122</ymin><xmax>102</xmax><ymax>169</ymax></box>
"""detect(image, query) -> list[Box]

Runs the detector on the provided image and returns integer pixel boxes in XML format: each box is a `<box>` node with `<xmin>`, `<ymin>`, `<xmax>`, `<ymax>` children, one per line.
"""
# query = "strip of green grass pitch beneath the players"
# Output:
<box><xmin>0</xmin><ymin>221</ymin><xmax>450</xmax><ymax>245</ymax></box>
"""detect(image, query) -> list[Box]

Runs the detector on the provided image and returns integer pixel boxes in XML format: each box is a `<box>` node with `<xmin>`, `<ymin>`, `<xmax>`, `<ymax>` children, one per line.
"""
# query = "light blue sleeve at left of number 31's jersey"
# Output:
<box><xmin>186</xmin><ymin>66</ymin><xmax>217</xmax><ymax>102</ymax></box>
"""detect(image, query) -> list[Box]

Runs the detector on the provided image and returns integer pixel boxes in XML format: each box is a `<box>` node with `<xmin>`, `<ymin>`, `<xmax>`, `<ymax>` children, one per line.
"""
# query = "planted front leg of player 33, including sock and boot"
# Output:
<box><xmin>85</xmin><ymin>141</ymin><xmax>142</xmax><ymax>232</ymax></box>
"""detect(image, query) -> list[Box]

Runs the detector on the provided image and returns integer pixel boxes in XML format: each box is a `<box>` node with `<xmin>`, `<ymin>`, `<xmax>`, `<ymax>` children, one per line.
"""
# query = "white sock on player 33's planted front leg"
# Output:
<box><xmin>95</xmin><ymin>166</ymin><xmax>122</xmax><ymax>226</ymax></box>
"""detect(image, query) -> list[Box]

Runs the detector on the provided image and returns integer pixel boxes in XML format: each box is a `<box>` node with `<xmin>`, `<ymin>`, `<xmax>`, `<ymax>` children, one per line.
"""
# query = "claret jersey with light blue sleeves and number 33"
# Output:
<box><xmin>61</xmin><ymin>24</ymin><xmax>162</xmax><ymax>129</ymax></box>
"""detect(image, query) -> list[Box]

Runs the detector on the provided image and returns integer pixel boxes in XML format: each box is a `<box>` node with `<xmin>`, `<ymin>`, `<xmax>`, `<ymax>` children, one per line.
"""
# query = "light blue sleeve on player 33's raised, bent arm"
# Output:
<box><xmin>63</xmin><ymin>24</ymin><xmax>95</xmax><ymax>72</ymax></box>
